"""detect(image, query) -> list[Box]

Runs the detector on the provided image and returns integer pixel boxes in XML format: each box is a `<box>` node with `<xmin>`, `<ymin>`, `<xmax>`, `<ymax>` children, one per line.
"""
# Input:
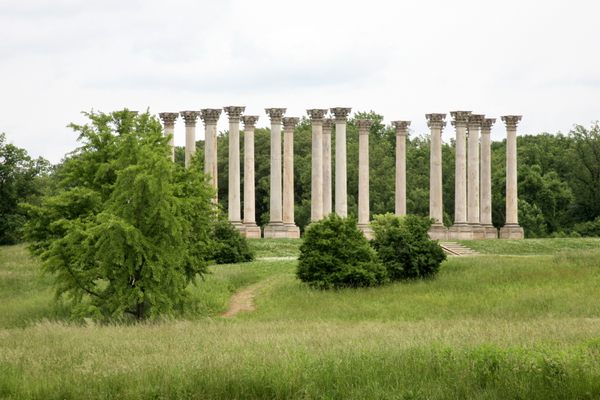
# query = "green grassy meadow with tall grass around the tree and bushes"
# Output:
<box><xmin>0</xmin><ymin>239</ymin><xmax>600</xmax><ymax>399</ymax></box>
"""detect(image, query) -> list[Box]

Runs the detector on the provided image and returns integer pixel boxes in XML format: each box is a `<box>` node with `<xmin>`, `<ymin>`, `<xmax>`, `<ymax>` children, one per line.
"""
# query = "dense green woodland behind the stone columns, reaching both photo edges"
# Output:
<box><xmin>0</xmin><ymin>112</ymin><xmax>600</xmax><ymax>243</ymax></box>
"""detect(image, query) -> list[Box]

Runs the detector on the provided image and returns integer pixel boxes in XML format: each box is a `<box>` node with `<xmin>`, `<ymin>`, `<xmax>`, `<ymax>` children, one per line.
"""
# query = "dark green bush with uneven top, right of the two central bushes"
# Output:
<box><xmin>371</xmin><ymin>214</ymin><xmax>446</xmax><ymax>281</ymax></box>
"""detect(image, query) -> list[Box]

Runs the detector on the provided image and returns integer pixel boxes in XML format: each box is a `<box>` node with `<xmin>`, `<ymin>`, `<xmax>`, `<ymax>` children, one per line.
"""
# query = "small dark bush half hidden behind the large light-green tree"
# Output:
<box><xmin>213</xmin><ymin>217</ymin><xmax>254</xmax><ymax>264</ymax></box>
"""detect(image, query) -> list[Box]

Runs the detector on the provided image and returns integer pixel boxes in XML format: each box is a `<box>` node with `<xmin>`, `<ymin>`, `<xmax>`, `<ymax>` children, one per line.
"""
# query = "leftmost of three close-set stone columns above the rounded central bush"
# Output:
<box><xmin>306</xmin><ymin>109</ymin><xmax>327</xmax><ymax>221</ymax></box>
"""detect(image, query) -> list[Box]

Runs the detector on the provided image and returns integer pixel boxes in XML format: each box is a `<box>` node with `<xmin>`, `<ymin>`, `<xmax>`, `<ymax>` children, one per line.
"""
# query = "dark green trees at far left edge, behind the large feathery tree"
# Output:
<box><xmin>0</xmin><ymin>133</ymin><xmax>50</xmax><ymax>244</ymax></box>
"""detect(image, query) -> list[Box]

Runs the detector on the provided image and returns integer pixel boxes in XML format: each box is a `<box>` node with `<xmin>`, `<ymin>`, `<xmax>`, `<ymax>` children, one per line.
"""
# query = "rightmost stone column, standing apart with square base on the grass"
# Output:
<box><xmin>500</xmin><ymin>115</ymin><xmax>524</xmax><ymax>239</ymax></box>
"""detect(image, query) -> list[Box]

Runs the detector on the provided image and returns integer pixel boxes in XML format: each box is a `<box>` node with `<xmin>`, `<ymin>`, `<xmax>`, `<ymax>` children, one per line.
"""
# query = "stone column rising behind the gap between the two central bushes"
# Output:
<box><xmin>356</xmin><ymin>119</ymin><xmax>373</xmax><ymax>239</ymax></box>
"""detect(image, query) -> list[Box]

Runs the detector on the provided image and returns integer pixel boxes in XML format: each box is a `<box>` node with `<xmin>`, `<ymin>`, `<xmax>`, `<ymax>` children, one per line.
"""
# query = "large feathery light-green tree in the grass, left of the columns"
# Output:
<box><xmin>26</xmin><ymin>110</ymin><xmax>215</xmax><ymax>320</ymax></box>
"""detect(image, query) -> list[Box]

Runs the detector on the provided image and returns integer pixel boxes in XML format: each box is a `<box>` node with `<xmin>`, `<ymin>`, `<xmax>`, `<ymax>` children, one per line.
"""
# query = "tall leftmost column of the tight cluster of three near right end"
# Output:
<box><xmin>448</xmin><ymin>111</ymin><xmax>473</xmax><ymax>240</ymax></box>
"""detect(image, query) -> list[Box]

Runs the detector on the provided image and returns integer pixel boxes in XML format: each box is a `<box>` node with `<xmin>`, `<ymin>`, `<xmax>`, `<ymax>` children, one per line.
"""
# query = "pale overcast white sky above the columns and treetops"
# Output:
<box><xmin>0</xmin><ymin>0</ymin><xmax>600</xmax><ymax>162</ymax></box>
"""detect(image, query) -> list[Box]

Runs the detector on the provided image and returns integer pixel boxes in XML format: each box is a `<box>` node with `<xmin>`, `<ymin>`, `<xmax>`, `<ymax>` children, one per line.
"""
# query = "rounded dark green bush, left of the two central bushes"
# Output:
<box><xmin>297</xmin><ymin>214</ymin><xmax>388</xmax><ymax>289</ymax></box>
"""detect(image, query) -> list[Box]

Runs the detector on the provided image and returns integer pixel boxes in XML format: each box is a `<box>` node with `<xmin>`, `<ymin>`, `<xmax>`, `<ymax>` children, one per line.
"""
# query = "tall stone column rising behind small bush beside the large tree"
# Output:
<box><xmin>223</xmin><ymin>106</ymin><xmax>246</xmax><ymax>230</ymax></box>
